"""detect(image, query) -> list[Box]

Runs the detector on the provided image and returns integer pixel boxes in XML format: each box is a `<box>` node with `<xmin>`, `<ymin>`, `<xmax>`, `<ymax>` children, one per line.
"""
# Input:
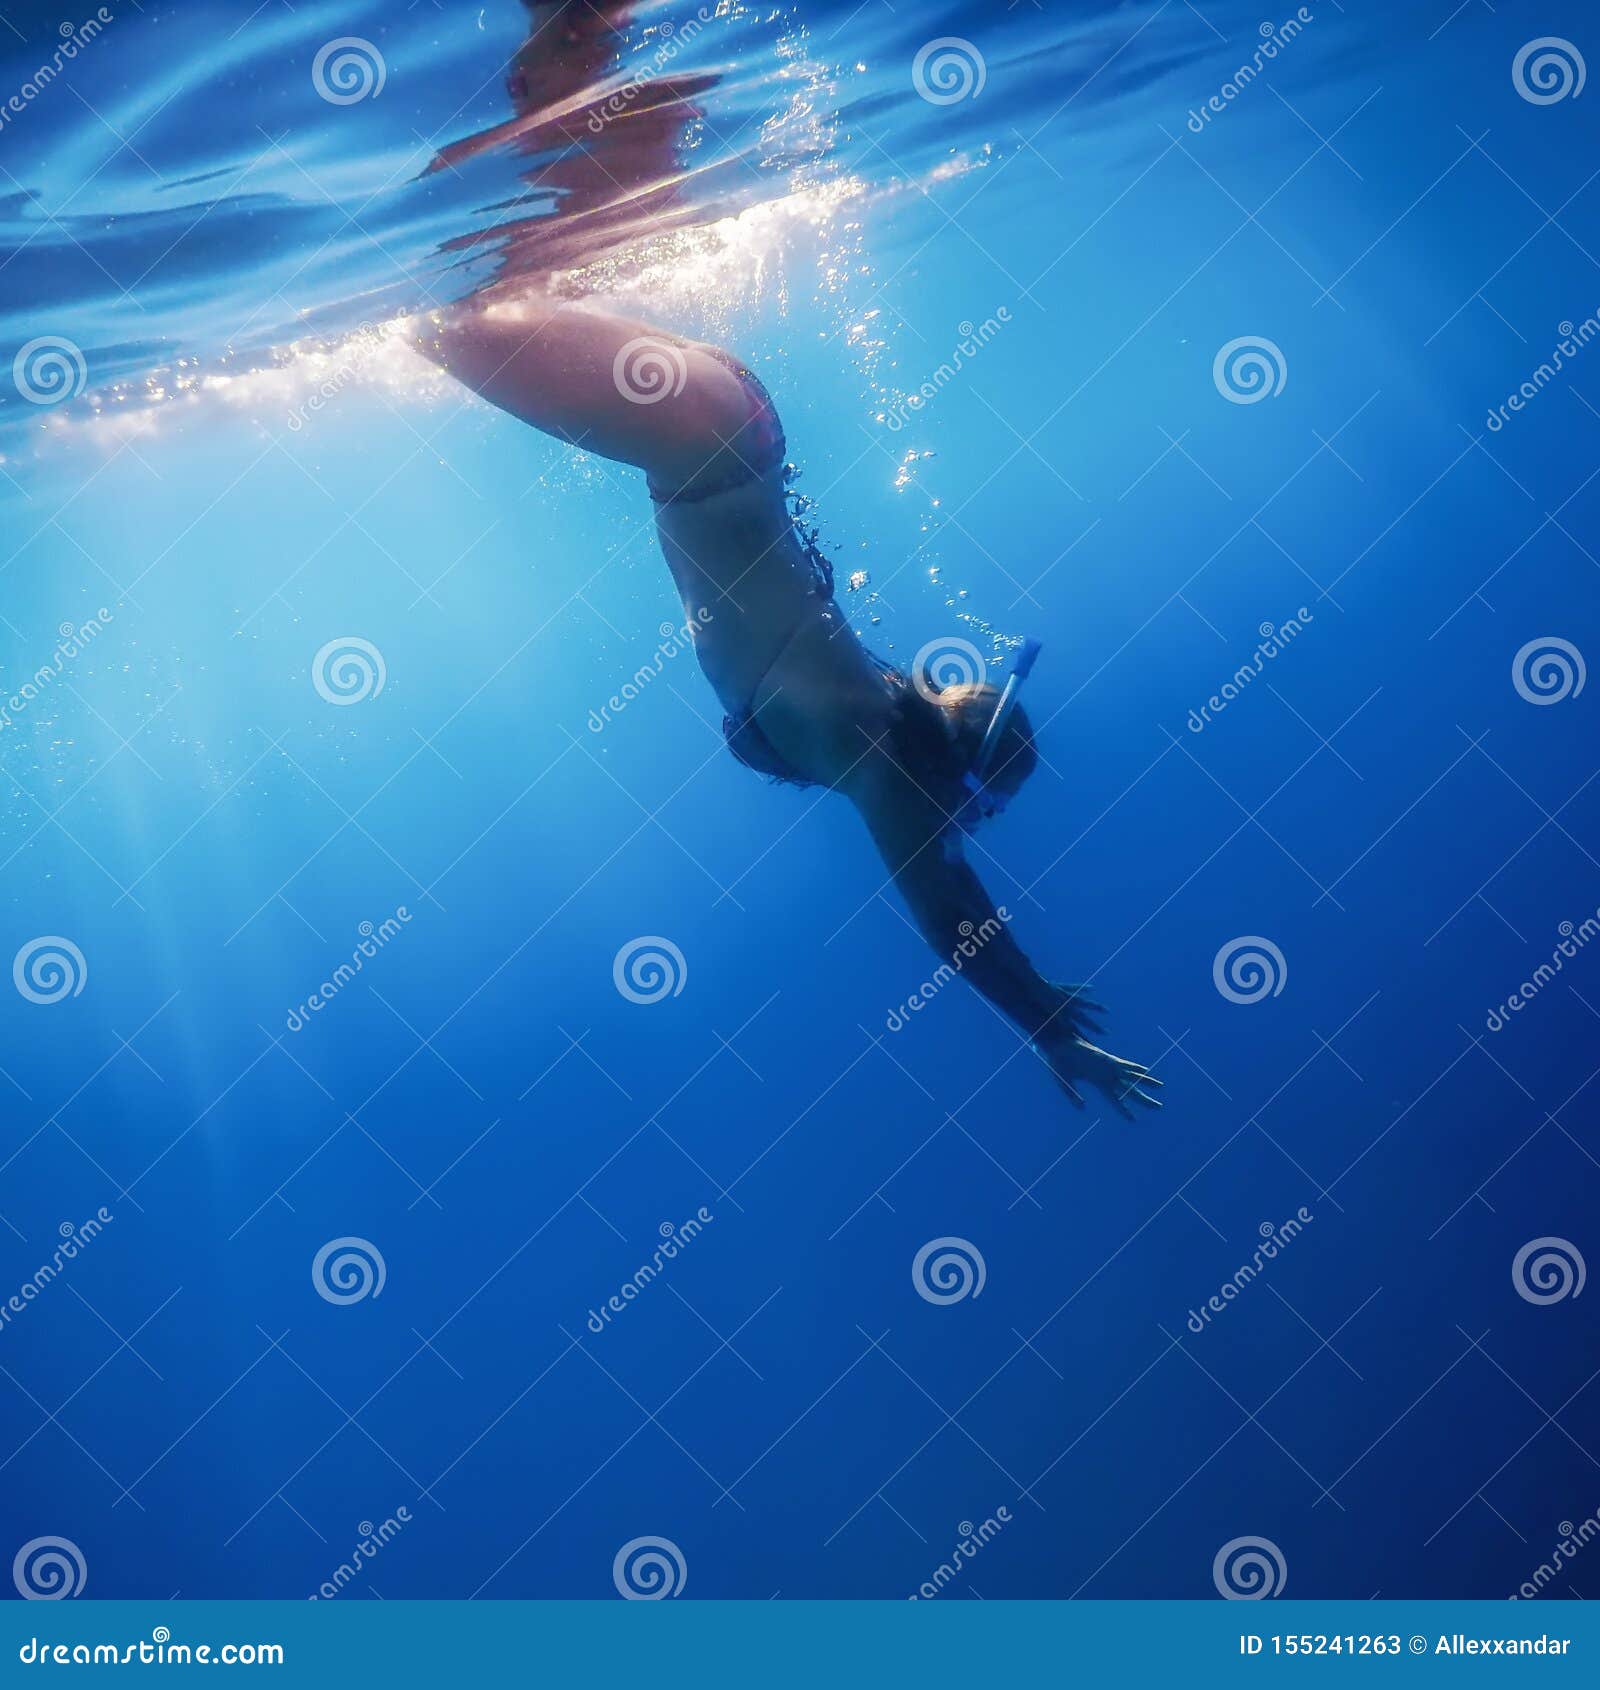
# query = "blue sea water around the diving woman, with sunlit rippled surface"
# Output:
<box><xmin>0</xmin><ymin>0</ymin><xmax>1600</xmax><ymax>1599</ymax></box>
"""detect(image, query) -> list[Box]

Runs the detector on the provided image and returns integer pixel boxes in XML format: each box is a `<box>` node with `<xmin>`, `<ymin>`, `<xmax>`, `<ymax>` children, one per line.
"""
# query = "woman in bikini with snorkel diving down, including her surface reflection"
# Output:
<box><xmin>414</xmin><ymin>0</ymin><xmax>1161</xmax><ymax>1119</ymax></box>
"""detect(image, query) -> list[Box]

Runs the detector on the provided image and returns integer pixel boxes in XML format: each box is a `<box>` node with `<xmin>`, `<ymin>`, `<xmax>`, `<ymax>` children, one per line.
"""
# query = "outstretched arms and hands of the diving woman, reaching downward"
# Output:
<box><xmin>843</xmin><ymin>754</ymin><xmax>1161</xmax><ymax>1120</ymax></box>
